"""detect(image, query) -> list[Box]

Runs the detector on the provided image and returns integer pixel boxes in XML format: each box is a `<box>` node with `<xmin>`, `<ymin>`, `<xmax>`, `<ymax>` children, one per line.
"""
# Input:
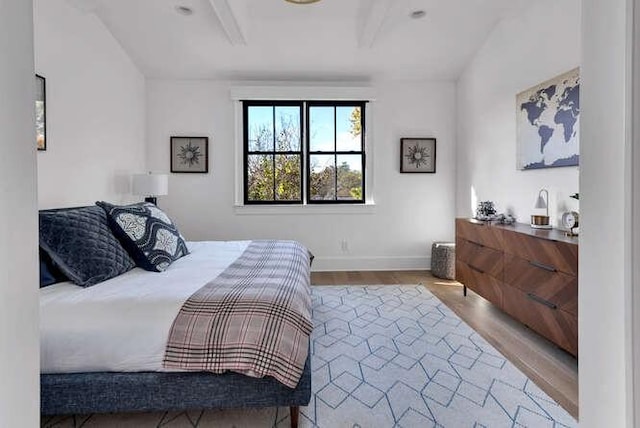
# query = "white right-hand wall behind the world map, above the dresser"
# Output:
<box><xmin>456</xmin><ymin>0</ymin><xmax>581</xmax><ymax>225</ymax></box>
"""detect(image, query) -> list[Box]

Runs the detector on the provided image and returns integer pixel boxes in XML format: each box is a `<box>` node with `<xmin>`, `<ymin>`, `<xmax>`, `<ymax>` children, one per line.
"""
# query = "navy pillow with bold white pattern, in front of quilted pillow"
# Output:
<box><xmin>96</xmin><ymin>201</ymin><xmax>189</xmax><ymax>272</ymax></box>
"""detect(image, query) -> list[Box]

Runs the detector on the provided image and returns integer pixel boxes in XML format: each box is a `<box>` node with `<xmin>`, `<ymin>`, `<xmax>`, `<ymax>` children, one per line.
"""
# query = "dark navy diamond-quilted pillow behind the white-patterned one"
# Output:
<box><xmin>39</xmin><ymin>207</ymin><xmax>135</xmax><ymax>287</ymax></box>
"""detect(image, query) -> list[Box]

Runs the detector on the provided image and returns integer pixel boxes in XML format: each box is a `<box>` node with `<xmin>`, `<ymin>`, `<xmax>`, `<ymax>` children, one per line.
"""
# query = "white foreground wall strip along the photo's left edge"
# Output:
<box><xmin>0</xmin><ymin>0</ymin><xmax>40</xmax><ymax>427</ymax></box>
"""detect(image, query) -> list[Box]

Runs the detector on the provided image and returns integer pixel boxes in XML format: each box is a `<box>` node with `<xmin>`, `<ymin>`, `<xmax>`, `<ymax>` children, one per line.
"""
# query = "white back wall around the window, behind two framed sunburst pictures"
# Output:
<box><xmin>147</xmin><ymin>80</ymin><xmax>455</xmax><ymax>270</ymax></box>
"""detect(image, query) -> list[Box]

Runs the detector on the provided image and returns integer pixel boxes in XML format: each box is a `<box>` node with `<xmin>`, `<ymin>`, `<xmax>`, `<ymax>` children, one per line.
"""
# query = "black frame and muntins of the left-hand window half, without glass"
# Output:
<box><xmin>242</xmin><ymin>100</ymin><xmax>305</xmax><ymax>205</ymax></box>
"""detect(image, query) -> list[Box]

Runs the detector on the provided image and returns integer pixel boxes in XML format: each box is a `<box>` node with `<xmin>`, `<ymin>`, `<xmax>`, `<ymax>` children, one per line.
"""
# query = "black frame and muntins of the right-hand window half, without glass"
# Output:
<box><xmin>304</xmin><ymin>100</ymin><xmax>367</xmax><ymax>205</ymax></box>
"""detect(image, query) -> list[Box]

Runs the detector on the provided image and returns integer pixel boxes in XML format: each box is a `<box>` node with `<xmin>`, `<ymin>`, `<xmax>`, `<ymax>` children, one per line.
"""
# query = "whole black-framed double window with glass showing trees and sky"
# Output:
<box><xmin>243</xmin><ymin>101</ymin><xmax>365</xmax><ymax>204</ymax></box>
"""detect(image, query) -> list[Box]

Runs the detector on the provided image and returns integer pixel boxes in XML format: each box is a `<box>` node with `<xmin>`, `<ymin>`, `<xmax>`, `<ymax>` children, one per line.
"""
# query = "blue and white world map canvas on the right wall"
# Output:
<box><xmin>516</xmin><ymin>68</ymin><xmax>580</xmax><ymax>170</ymax></box>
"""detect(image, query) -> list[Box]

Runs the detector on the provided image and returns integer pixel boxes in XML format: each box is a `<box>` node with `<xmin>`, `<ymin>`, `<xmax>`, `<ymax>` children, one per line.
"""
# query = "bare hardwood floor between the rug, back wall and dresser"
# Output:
<box><xmin>311</xmin><ymin>271</ymin><xmax>578</xmax><ymax>419</ymax></box>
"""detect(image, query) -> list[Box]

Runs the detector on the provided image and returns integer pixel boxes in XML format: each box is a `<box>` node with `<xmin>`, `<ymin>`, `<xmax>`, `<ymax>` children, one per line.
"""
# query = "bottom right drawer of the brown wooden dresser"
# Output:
<box><xmin>502</xmin><ymin>287</ymin><xmax>578</xmax><ymax>356</ymax></box>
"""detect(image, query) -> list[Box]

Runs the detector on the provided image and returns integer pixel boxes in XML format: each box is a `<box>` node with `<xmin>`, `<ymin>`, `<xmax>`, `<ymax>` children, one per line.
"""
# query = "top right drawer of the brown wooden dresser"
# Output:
<box><xmin>504</xmin><ymin>230</ymin><xmax>578</xmax><ymax>276</ymax></box>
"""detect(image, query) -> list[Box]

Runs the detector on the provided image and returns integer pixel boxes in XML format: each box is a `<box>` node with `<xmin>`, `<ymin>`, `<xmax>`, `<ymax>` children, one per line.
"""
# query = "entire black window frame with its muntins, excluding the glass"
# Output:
<box><xmin>241</xmin><ymin>100</ymin><xmax>367</xmax><ymax>205</ymax></box>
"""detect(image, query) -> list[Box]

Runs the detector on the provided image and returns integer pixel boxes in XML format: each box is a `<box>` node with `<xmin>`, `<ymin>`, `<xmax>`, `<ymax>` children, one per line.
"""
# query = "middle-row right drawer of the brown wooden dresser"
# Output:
<box><xmin>504</xmin><ymin>254</ymin><xmax>578</xmax><ymax>316</ymax></box>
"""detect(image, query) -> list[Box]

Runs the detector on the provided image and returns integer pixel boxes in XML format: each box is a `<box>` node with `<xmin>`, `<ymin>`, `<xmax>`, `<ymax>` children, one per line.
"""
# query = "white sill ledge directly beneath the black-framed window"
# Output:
<box><xmin>233</xmin><ymin>202</ymin><xmax>376</xmax><ymax>215</ymax></box>
